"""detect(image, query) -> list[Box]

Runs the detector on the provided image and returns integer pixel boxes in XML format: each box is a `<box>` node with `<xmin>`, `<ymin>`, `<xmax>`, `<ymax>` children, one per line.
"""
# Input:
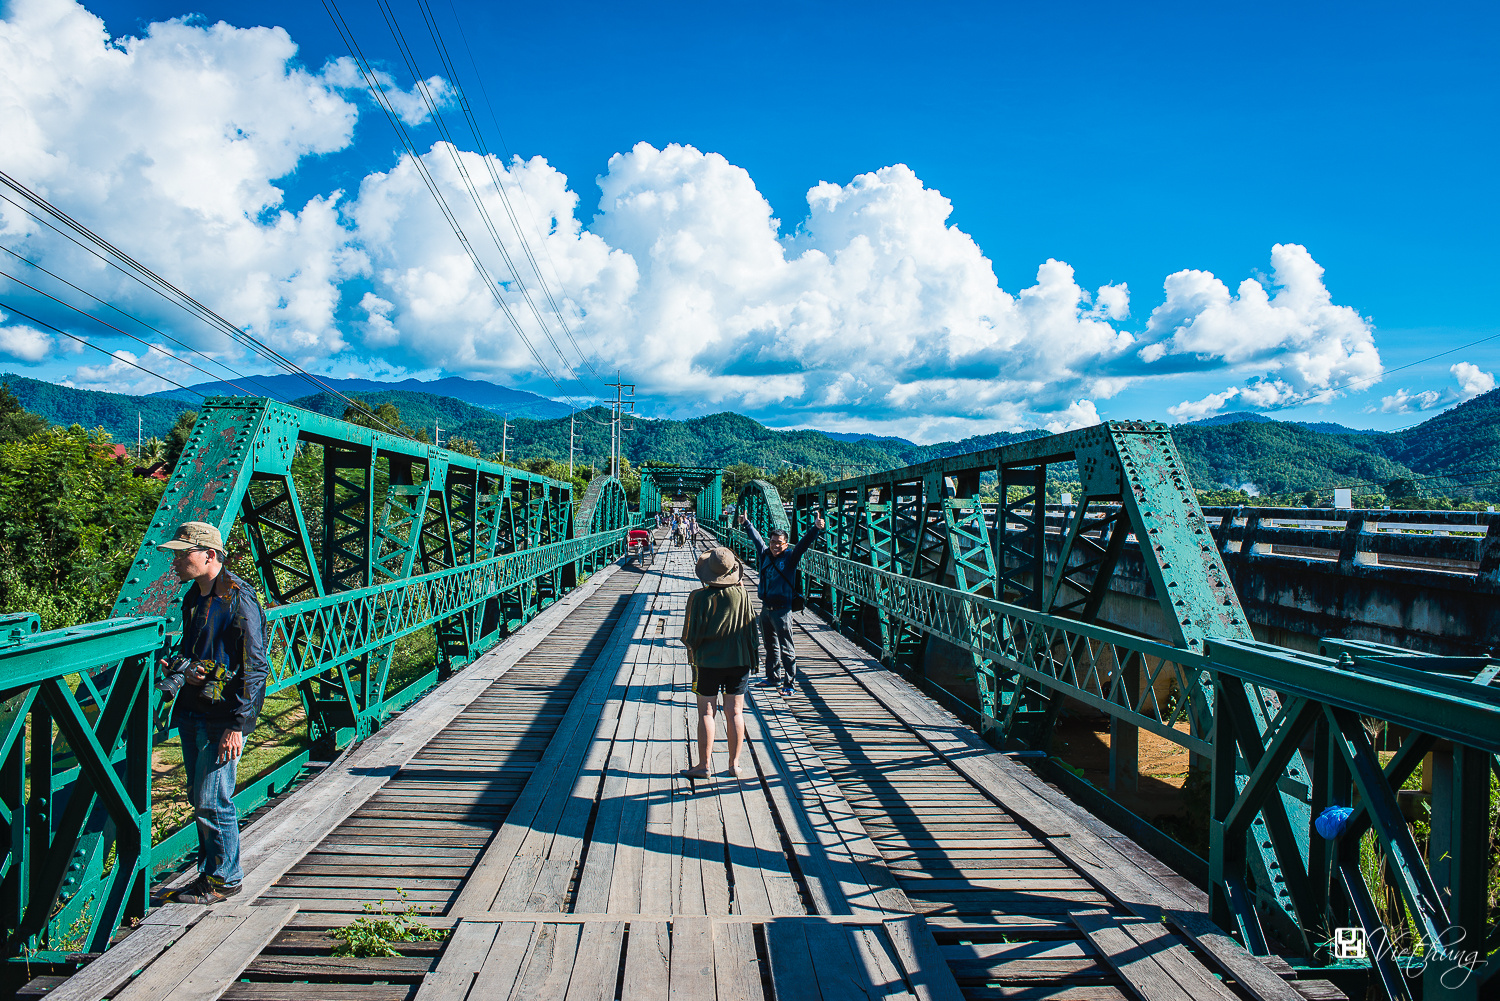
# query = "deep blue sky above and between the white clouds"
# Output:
<box><xmin>0</xmin><ymin>0</ymin><xmax>1500</xmax><ymax>437</ymax></box>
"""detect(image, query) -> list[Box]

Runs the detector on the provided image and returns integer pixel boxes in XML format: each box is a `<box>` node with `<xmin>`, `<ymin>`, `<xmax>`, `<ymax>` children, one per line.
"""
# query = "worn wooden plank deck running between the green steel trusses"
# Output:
<box><xmin>33</xmin><ymin>537</ymin><xmax>1341</xmax><ymax>1001</ymax></box>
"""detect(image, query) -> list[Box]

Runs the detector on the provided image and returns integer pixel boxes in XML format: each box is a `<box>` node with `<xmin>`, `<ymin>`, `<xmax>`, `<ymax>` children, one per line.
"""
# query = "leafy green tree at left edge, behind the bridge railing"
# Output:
<box><xmin>0</xmin><ymin>425</ymin><xmax>162</xmax><ymax>629</ymax></box>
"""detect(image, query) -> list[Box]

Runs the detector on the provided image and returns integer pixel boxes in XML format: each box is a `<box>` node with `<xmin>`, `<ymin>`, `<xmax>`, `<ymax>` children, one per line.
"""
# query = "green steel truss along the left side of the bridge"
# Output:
<box><xmin>0</xmin><ymin>398</ymin><xmax>630</xmax><ymax>959</ymax></box>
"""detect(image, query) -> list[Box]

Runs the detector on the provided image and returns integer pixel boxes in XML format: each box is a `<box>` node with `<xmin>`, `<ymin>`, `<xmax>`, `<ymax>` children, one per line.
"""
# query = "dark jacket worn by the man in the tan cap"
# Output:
<box><xmin>173</xmin><ymin>570</ymin><xmax>270</xmax><ymax>737</ymax></box>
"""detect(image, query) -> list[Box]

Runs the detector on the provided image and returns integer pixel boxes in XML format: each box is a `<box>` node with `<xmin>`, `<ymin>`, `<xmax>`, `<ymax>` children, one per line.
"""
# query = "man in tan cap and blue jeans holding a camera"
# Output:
<box><xmin>156</xmin><ymin>521</ymin><xmax>270</xmax><ymax>903</ymax></box>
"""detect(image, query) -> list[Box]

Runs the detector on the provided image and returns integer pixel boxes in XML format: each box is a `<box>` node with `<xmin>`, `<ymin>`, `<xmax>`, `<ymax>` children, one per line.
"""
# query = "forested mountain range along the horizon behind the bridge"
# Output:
<box><xmin>0</xmin><ymin>375</ymin><xmax>1500</xmax><ymax>500</ymax></box>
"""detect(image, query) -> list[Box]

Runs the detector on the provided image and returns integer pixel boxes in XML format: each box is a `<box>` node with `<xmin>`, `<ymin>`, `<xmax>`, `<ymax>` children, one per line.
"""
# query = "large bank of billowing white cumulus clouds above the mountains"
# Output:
<box><xmin>0</xmin><ymin>0</ymin><xmax>1404</xmax><ymax>440</ymax></box>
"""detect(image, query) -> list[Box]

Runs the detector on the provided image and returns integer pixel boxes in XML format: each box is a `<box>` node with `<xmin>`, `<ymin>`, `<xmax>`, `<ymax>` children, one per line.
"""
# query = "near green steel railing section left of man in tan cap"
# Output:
<box><xmin>0</xmin><ymin>615</ymin><xmax>165</xmax><ymax>956</ymax></box>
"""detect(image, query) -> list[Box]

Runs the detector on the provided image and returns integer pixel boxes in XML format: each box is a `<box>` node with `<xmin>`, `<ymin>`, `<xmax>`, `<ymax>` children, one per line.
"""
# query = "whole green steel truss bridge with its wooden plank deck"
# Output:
<box><xmin>0</xmin><ymin>408</ymin><xmax>1500</xmax><ymax>1001</ymax></box>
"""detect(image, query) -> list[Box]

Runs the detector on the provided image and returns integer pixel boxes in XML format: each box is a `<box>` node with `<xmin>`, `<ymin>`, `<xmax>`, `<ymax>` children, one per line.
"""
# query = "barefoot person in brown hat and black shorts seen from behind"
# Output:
<box><xmin>683</xmin><ymin>546</ymin><xmax>756</xmax><ymax>779</ymax></box>
